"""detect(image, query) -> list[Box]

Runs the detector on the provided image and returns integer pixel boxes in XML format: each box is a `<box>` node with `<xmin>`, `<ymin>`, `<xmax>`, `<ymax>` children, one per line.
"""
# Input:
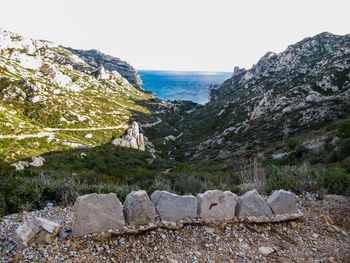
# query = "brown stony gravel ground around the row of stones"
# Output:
<box><xmin>0</xmin><ymin>194</ymin><xmax>350</xmax><ymax>263</ymax></box>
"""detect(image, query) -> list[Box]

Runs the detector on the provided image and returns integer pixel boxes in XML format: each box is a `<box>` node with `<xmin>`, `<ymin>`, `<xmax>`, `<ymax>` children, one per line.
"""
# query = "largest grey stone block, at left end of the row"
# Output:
<box><xmin>72</xmin><ymin>193</ymin><xmax>124</xmax><ymax>237</ymax></box>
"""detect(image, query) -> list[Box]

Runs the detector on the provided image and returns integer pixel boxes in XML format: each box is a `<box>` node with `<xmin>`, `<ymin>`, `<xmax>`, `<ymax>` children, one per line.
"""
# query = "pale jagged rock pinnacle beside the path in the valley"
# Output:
<box><xmin>112</xmin><ymin>121</ymin><xmax>145</xmax><ymax>151</ymax></box>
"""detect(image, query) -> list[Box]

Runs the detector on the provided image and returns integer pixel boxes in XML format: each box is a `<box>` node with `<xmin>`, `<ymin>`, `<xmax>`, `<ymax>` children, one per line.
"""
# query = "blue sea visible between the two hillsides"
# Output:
<box><xmin>138</xmin><ymin>70</ymin><xmax>232</xmax><ymax>104</ymax></box>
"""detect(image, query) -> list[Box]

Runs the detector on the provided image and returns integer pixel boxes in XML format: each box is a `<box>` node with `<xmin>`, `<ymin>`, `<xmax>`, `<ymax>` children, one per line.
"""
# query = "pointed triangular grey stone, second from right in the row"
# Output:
<box><xmin>236</xmin><ymin>189</ymin><xmax>272</xmax><ymax>217</ymax></box>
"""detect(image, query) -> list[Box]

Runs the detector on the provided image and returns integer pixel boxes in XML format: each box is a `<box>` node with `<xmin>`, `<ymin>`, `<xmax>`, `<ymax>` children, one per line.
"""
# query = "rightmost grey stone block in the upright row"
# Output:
<box><xmin>266</xmin><ymin>190</ymin><xmax>298</xmax><ymax>214</ymax></box>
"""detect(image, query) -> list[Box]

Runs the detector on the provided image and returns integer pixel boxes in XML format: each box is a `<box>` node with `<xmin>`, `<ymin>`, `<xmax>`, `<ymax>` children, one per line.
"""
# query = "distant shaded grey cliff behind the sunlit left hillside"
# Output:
<box><xmin>66</xmin><ymin>48</ymin><xmax>142</xmax><ymax>85</ymax></box>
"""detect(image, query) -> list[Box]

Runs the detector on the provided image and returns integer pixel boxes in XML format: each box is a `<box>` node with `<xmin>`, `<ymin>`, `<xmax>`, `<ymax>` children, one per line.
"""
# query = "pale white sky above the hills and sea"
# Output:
<box><xmin>0</xmin><ymin>0</ymin><xmax>350</xmax><ymax>72</ymax></box>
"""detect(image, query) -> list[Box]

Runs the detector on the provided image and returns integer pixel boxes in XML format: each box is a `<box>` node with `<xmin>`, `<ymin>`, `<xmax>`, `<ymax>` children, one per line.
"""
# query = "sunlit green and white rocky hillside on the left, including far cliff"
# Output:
<box><xmin>0</xmin><ymin>29</ymin><xmax>151</xmax><ymax>162</ymax></box>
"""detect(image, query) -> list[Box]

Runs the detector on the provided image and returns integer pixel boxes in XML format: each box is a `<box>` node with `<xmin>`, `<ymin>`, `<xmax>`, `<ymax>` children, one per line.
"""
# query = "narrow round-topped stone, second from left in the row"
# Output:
<box><xmin>124</xmin><ymin>190</ymin><xmax>156</xmax><ymax>225</ymax></box>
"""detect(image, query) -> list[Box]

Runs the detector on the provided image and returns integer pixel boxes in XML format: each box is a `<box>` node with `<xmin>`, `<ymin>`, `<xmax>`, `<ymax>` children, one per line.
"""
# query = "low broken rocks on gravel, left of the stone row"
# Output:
<box><xmin>12</xmin><ymin>217</ymin><xmax>62</xmax><ymax>249</ymax></box>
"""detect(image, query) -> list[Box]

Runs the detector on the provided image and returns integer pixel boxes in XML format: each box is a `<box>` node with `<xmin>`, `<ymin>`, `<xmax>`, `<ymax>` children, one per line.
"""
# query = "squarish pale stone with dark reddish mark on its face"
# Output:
<box><xmin>197</xmin><ymin>190</ymin><xmax>238</xmax><ymax>221</ymax></box>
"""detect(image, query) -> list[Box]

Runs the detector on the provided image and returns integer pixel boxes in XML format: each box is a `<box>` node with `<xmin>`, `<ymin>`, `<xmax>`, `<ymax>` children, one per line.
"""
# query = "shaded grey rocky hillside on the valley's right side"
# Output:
<box><xmin>146</xmin><ymin>33</ymin><xmax>350</xmax><ymax>160</ymax></box>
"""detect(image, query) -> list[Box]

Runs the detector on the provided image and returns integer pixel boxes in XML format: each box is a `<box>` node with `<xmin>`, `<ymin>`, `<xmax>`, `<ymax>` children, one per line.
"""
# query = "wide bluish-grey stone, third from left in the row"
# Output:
<box><xmin>151</xmin><ymin>190</ymin><xmax>198</xmax><ymax>221</ymax></box>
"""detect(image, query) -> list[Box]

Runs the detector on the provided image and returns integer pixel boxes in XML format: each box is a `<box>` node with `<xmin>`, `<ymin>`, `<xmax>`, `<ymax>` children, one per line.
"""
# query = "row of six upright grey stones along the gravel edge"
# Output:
<box><xmin>72</xmin><ymin>190</ymin><xmax>299</xmax><ymax>237</ymax></box>
